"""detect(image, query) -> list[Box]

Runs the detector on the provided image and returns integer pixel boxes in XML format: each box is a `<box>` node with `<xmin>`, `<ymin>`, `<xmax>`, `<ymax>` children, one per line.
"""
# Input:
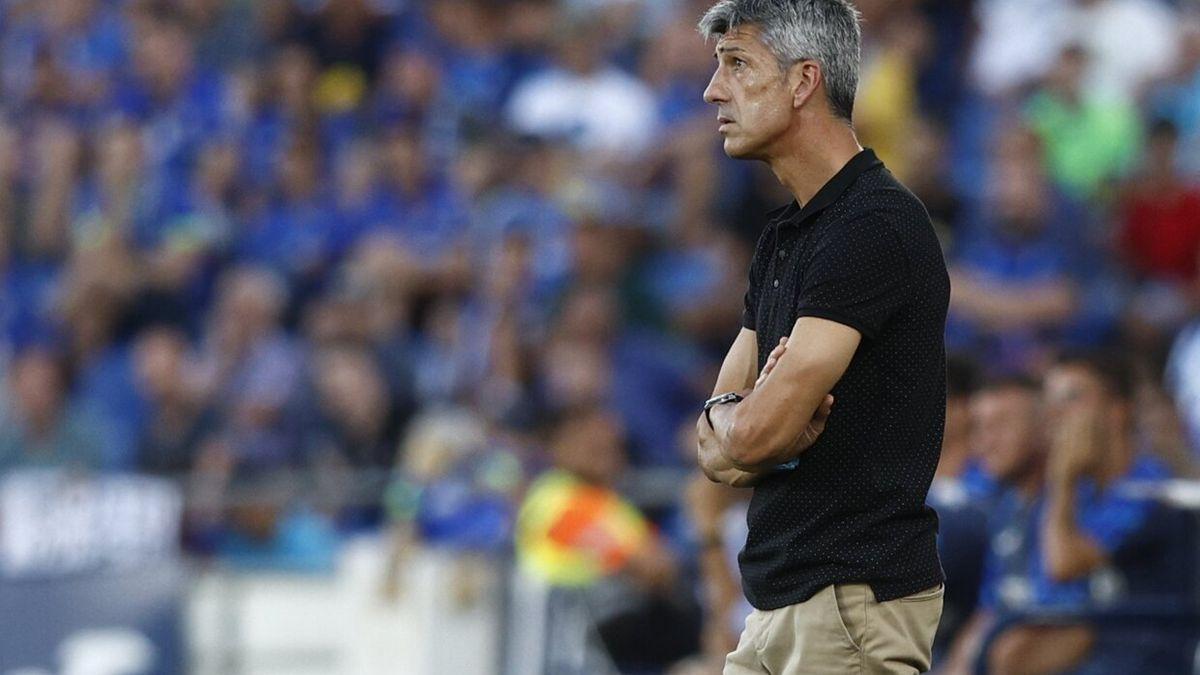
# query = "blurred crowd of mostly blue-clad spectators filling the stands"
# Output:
<box><xmin>0</xmin><ymin>0</ymin><xmax>1200</xmax><ymax>671</ymax></box>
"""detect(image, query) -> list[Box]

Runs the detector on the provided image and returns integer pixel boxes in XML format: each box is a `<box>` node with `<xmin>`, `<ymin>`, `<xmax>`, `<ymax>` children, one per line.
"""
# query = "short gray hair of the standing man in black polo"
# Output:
<box><xmin>698</xmin><ymin>0</ymin><xmax>863</xmax><ymax>121</ymax></box>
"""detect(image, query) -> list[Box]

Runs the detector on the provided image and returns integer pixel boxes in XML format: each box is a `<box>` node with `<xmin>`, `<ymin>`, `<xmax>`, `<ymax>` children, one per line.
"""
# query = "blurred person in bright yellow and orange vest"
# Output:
<box><xmin>516</xmin><ymin>407</ymin><xmax>698</xmax><ymax>670</ymax></box>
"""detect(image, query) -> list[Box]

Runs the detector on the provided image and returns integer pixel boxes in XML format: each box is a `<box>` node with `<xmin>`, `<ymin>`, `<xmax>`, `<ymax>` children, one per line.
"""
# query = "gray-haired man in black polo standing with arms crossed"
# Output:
<box><xmin>696</xmin><ymin>0</ymin><xmax>949</xmax><ymax>674</ymax></box>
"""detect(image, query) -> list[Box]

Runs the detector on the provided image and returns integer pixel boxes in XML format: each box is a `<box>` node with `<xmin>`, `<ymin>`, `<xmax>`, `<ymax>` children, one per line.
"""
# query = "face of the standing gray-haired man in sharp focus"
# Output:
<box><xmin>704</xmin><ymin>25</ymin><xmax>793</xmax><ymax>160</ymax></box>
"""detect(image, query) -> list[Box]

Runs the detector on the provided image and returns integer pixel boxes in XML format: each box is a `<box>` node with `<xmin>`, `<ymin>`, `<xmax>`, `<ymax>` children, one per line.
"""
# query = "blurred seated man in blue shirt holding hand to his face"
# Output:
<box><xmin>952</xmin><ymin>353</ymin><xmax>1170</xmax><ymax>673</ymax></box>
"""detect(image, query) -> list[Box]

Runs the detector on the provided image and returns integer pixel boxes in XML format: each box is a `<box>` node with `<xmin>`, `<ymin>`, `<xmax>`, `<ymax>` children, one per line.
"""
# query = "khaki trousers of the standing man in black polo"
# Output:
<box><xmin>725</xmin><ymin>584</ymin><xmax>946</xmax><ymax>675</ymax></box>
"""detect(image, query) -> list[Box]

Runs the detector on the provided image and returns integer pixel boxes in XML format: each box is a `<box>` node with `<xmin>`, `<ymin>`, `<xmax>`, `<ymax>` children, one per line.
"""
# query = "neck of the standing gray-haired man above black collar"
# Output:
<box><xmin>767</xmin><ymin>118</ymin><xmax>863</xmax><ymax>207</ymax></box>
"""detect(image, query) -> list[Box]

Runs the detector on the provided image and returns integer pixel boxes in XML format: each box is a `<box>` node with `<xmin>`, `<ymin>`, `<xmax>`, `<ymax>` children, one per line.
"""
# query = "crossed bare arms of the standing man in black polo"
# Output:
<box><xmin>696</xmin><ymin>317</ymin><xmax>862</xmax><ymax>488</ymax></box>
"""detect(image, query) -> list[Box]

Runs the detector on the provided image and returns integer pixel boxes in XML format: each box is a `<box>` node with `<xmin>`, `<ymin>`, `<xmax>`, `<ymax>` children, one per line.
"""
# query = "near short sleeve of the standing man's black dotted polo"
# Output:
<box><xmin>797</xmin><ymin>215</ymin><xmax>912</xmax><ymax>338</ymax></box>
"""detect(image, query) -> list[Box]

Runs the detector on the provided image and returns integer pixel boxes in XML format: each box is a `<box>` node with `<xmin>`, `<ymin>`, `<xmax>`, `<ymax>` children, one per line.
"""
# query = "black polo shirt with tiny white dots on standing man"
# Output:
<box><xmin>738</xmin><ymin>150</ymin><xmax>950</xmax><ymax>610</ymax></box>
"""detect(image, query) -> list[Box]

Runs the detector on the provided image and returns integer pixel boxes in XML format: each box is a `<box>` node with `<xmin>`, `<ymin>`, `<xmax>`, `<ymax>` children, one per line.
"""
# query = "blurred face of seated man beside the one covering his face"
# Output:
<box><xmin>971</xmin><ymin>387</ymin><xmax>1038</xmax><ymax>480</ymax></box>
